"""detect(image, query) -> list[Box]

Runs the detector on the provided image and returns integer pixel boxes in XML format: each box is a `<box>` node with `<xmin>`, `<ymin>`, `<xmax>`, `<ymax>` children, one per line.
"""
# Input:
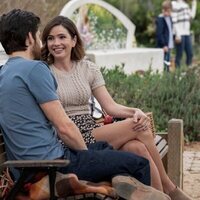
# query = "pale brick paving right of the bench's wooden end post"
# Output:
<box><xmin>183</xmin><ymin>151</ymin><xmax>200</xmax><ymax>200</ymax></box>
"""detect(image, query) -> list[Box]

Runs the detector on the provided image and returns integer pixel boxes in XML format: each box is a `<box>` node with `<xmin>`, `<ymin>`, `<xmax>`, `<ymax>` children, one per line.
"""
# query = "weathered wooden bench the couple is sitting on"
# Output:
<box><xmin>0</xmin><ymin>115</ymin><xmax>183</xmax><ymax>200</ymax></box>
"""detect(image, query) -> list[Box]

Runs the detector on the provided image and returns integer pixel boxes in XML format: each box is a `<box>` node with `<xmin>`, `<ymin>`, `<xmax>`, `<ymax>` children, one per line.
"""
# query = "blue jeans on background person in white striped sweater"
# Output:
<box><xmin>175</xmin><ymin>35</ymin><xmax>193</xmax><ymax>67</ymax></box>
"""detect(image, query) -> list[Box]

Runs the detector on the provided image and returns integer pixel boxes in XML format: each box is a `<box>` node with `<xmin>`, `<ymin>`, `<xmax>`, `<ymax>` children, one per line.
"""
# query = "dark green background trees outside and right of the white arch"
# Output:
<box><xmin>105</xmin><ymin>0</ymin><xmax>200</xmax><ymax>46</ymax></box>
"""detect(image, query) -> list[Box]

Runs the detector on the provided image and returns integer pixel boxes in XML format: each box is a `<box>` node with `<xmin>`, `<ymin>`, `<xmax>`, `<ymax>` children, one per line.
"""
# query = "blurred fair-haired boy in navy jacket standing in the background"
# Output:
<box><xmin>156</xmin><ymin>0</ymin><xmax>174</xmax><ymax>72</ymax></box>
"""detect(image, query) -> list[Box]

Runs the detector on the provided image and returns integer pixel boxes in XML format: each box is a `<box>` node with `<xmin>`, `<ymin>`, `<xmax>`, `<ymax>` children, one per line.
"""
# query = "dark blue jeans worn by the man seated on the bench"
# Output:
<box><xmin>59</xmin><ymin>142</ymin><xmax>150</xmax><ymax>185</ymax></box>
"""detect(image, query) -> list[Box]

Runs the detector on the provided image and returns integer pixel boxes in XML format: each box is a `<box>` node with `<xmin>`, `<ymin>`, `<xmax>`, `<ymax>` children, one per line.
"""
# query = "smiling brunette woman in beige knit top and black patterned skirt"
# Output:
<box><xmin>42</xmin><ymin>16</ymin><xmax>190</xmax><ymax>200</ymax></box>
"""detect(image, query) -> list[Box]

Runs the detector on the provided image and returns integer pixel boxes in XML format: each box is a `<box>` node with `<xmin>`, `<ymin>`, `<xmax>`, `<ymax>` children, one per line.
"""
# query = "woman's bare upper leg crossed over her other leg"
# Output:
<box><xmin>92</xmin><ymin>119</ymin><xmax>175</xmax><ymax>194</ymax></box>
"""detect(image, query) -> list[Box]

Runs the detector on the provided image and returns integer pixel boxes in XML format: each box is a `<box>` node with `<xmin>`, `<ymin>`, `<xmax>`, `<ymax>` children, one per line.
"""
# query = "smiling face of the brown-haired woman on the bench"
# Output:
<box><xmin>47</xmin><ymin>25</ymin><xmax>76</xmax><ymax>60</ymax></box>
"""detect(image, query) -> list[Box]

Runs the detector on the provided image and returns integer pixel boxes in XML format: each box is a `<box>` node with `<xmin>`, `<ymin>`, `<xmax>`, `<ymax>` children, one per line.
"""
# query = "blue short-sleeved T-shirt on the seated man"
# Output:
<box><xmin>0</xmin><ymin>57</ymin><xmax>63</xmax><ymax>160</ymax></box>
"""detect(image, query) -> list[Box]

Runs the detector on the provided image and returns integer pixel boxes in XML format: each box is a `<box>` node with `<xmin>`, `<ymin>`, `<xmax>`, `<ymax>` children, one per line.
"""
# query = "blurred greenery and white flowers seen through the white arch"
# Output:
<box><xmin>88</xmin><ymin>4</ymin><xmax>127</xmax><ymax>49</ymax></box>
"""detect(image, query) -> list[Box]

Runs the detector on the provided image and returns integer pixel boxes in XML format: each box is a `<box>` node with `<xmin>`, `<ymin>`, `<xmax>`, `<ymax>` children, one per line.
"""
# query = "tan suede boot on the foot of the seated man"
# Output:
<box><xmin>112</xmin><ymin>175</ymin><xmax>171</xmax><ymax>200</ymax></box>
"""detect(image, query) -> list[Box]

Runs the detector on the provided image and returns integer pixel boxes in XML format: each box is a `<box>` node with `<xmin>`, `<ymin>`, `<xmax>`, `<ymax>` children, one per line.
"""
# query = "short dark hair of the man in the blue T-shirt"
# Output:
<box><xmin>0</xmin><ymin>9</ymin><xmax>40</xmax><ymax>54</ymax></box>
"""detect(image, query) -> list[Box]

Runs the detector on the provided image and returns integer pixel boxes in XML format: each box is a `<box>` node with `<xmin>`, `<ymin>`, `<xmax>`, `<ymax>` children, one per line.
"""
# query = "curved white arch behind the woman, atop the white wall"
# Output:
<box><xmin>60</xmin><ymin>0</ymin><xmax>135</xmax><ymax>49</ymax></box>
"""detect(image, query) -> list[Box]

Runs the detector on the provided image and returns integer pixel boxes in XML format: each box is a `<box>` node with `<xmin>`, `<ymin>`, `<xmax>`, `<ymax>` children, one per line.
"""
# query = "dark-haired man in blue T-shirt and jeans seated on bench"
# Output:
<box><xmin>0</xmin><ymin>9</ymin><xmax>170</xmax><ymax>199</ymax></box>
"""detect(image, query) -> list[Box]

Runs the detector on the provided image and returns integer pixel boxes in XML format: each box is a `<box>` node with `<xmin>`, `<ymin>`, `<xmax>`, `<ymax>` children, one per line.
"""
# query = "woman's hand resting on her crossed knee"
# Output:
<box><xmin>133</xmin><ymin>109</ymin><xmax>150</xmax><ymax>131</ymax></box>
